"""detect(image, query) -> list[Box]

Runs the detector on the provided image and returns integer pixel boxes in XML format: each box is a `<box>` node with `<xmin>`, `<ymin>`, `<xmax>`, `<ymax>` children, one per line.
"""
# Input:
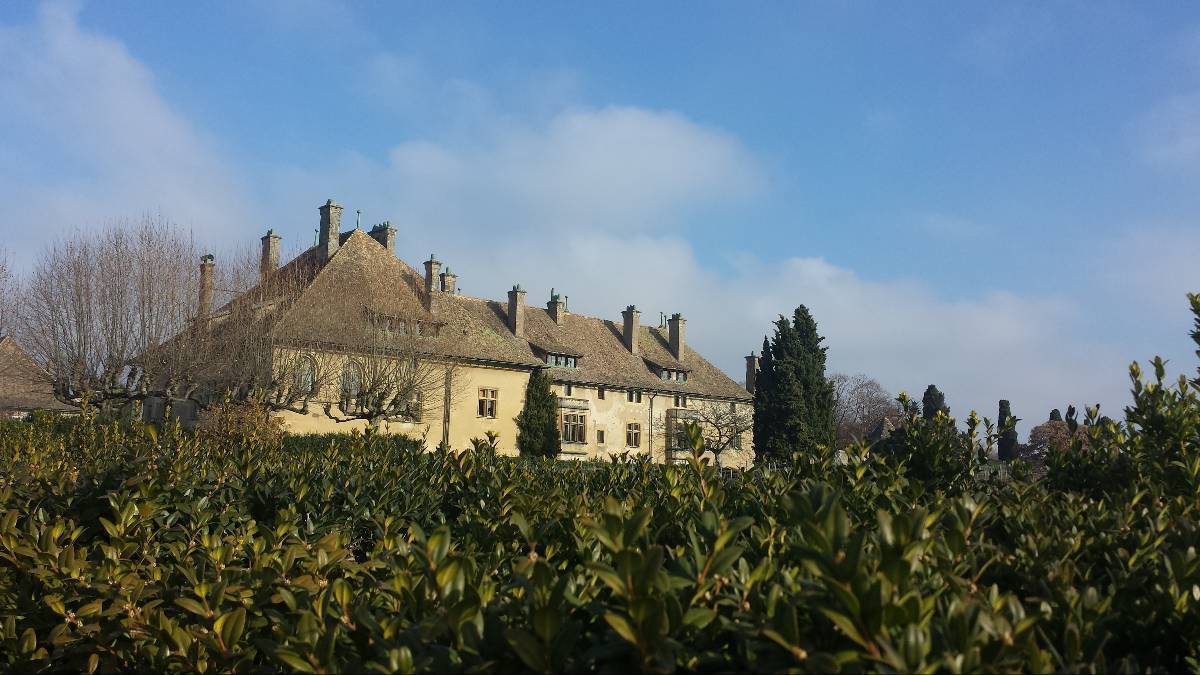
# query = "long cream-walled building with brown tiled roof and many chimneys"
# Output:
<box><xmin>197</xmin><ymin>201</ymin><xmax>754</xmax><ymax>465</ymax></box>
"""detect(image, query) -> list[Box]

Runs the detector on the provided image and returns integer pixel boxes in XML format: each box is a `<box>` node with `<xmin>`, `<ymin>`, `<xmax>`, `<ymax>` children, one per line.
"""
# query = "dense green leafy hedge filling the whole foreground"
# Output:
<box><xmin>0</xmin><ymin>348</ymin><xmax>1200</xmax><ymax>671</ymax></box>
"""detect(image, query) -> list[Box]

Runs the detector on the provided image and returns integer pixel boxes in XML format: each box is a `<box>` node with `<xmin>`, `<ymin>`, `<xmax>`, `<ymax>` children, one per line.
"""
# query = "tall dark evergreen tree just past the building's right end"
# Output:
<box><xmin>754</xmin><ymin>305</ymin><xmax>834</xmax><ymax>458</ymax></box>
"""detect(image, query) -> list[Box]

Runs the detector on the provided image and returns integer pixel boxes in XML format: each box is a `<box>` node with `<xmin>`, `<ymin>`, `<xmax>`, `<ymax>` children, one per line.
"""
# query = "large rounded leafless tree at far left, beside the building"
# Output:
<box><xmin>17</xmin><ymin>216</ymin><xmax>198</xmax><ymax>408</ymax></box>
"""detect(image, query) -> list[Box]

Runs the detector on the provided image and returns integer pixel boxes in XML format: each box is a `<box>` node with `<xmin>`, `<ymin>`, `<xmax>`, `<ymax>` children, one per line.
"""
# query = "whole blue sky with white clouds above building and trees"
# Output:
<box><xmin>0</xmin><ymin>0</ymin><xmax>1200</xmax><ymax>427</ymax></box>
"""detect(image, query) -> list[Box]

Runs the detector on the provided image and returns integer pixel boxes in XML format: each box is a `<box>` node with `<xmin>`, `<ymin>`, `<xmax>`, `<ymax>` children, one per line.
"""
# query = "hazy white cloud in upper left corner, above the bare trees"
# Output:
<box><xmin>0</xmin><ymin>4</ymin><xmax>250</xmax><ymax>263</ymax></box>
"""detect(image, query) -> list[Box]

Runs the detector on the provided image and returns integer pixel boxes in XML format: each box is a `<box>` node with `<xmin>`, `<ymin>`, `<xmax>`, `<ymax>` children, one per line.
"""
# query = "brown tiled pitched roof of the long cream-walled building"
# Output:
<box><xmin>262</xmin><ymin>229</ymin><xmax>751</xmax><ymax>400</ymax></box>
